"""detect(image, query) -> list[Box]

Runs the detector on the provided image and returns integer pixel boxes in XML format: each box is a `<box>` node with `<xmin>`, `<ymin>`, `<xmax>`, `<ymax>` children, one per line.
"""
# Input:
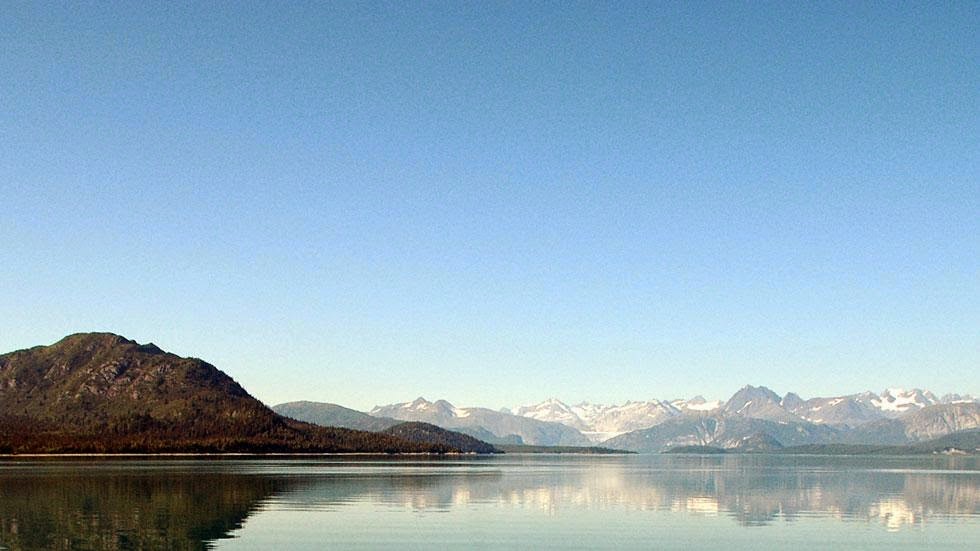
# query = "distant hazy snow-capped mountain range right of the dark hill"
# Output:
<box><xmin>274</xmin><ymin>385</ymin><xmax>980</xmax><ymax>452</ymax></box>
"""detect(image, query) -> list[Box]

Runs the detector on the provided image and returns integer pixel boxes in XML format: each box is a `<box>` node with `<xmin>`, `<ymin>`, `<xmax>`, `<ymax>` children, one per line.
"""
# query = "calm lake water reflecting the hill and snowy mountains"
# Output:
<box><xmin>0</xmin><ymin>455</ymin><xmax>980</xmax><ymax>550</ymax></box>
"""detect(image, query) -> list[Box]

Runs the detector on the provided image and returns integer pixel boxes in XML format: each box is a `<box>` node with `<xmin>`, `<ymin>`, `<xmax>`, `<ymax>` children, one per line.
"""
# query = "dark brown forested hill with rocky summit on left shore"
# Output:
<box><xmin>0</xmin><ymin>333</ymin><xmax>490</xmax><ymax>453</ymax></box>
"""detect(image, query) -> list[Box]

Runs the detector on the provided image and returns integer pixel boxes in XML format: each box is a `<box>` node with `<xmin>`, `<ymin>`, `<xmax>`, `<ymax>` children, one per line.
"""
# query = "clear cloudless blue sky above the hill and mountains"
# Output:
<box><xmin>0</xmin><ymin>2</ymin><xmax>980</xmax><ymax>409</ymax></box>
